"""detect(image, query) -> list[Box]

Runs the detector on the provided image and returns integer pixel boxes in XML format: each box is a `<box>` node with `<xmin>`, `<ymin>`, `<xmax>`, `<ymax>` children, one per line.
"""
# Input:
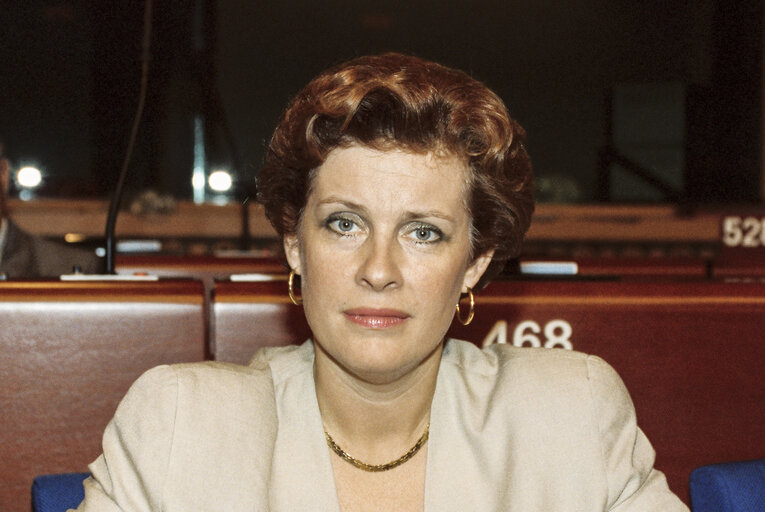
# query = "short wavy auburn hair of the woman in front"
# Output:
<box><xmin>257</xmin><ymin>53</ymin><xmax>534</xmax><ymax>287</ymax></box>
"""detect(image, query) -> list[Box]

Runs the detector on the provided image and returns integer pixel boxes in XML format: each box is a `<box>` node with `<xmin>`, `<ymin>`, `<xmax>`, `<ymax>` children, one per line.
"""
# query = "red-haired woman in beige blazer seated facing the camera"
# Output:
<box><xmin>79</xmin><ymin>54</ymin><xmax>687</xmax><ymax>512</ymax></box>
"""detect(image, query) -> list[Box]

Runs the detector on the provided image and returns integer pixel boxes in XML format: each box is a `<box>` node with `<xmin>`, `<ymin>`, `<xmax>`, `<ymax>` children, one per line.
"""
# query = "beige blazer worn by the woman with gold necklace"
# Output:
<box><xmin>71</xmin><ymin>340</ymin><xmax>688</xmax><ymax>512</ymax></box>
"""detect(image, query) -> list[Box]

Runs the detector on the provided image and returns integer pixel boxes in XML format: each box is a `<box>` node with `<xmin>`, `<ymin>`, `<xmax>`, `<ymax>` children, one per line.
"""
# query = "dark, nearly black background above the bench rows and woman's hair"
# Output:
<box><xmin>0</xmin><ymin>0</ymin><xmax>763</xmax><ymax>203</ymax></box>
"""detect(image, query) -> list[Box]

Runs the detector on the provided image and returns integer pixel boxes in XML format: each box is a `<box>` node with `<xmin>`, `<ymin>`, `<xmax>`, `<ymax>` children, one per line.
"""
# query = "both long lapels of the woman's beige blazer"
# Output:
<box><xmin>267</xmin><ymin>340</ymin><xmax>493</xmax><ymax>512</ymax></box>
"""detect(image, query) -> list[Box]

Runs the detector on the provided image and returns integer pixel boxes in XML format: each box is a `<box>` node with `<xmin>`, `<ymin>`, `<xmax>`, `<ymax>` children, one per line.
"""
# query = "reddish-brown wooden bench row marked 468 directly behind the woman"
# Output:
<box><xmin>0</xmin><ymin>280</ymin><xmax>765</xmax><ymax>511</ymax></box>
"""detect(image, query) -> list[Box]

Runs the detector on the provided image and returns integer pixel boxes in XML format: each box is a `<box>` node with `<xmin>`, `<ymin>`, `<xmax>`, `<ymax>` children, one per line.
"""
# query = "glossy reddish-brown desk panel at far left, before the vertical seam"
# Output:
<box><xmin>0</xmin><ymin>281</ymin><xmax>207</xmax><ymax>512</ymax></box>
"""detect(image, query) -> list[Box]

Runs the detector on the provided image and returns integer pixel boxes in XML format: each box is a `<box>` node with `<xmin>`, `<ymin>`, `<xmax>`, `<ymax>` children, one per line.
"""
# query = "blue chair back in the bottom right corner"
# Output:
<box><xmin>691</xmin><ymin>459</ymin><xmax>765</xmax><ymax>512</ymax></box>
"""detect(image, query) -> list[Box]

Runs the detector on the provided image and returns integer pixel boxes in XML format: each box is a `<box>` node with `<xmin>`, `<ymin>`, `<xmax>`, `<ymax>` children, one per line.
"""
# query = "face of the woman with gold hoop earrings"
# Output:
<box><xmin>284</xmin><ymin>146</ymin><xmax>491</xmax><ymax>382</ymax></box>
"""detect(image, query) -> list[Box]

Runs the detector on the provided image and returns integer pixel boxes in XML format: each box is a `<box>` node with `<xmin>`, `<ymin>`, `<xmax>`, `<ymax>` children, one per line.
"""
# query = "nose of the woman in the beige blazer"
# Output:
<box><xmin>357</xmin><ymin>236</ymin><xmax>403</xmax><ymax>291</ymax></box>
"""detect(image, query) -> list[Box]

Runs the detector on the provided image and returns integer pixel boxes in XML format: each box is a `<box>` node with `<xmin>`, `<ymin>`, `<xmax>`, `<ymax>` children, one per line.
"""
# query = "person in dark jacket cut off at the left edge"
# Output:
<box><xmin>0</xmin><ymin>140</ymin><xmax>103</xmax><ymax>279</ymax></box>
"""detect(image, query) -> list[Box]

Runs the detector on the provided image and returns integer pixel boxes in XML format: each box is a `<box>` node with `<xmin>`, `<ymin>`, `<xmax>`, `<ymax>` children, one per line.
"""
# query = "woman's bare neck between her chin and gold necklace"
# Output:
<box><xmin>314</xmin><ymin>344</ymin><xmax>443</xmax><ymax>464</ymax></box>
